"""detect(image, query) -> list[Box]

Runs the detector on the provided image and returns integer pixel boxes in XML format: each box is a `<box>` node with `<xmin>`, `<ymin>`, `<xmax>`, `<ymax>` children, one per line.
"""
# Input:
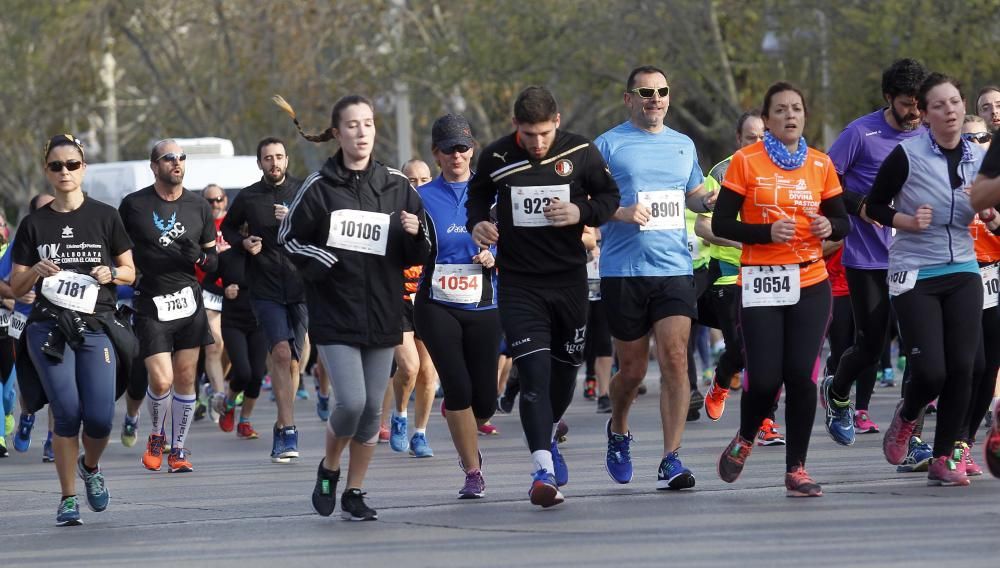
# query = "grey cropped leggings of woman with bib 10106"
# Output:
<box><xmin>316</xmin><ymin>343</ymin><xmax>393</xmax><ymax>445</ymax></box>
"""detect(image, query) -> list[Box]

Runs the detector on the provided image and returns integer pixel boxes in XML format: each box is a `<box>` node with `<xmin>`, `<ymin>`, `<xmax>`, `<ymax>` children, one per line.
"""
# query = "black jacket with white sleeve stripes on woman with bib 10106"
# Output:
<box><xmin>278</xmin><ymin>151</ymin><xmax>430</xmax><ymax>347</ymax></box>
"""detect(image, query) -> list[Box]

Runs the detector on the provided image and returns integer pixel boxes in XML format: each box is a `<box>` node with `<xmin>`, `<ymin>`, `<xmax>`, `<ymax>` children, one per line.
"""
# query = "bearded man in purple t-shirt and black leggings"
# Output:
<box><xmin>820</xmin><ymin>59</ymin><xmax>927</xmax><ymax>451</ymax></box>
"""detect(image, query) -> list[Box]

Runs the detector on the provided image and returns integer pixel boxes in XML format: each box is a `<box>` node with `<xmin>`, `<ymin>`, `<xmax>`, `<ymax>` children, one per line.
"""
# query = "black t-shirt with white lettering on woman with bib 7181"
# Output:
<box><xmin>11</xmin><ymin>197</ymin><xmax>132</xmax><ymax>312</ymax></box>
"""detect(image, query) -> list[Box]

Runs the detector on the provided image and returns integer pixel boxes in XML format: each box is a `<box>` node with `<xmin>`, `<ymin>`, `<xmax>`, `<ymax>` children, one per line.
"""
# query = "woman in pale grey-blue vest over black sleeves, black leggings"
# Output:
<box><xmin>872</xmin><ymin>73</ymin><xmax>986</xmax><ymax>486</ymax></box>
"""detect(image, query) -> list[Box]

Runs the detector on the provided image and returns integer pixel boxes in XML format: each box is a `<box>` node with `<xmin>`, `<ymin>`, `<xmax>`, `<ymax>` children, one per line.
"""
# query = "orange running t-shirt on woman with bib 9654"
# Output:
<box><xmin>722</xmin><ymin>142</ymin><xmax>843</xmax><ymax>288</ymax></box>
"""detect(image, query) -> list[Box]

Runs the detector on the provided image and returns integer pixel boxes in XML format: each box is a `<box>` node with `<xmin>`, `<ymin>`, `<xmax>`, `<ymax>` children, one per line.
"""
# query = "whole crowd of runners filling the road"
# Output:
<box><xmin>0</xmin><ymin>59</ymin><xmax>1000</xmax><ymax>526</ymax></box>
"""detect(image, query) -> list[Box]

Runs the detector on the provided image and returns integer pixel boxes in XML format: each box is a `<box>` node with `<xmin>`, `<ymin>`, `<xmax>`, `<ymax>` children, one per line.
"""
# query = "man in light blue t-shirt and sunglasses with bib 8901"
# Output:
<box><xmin>594</xmin><ymin>66</ymin><xmax>715</xmax><ymax>489</ymax></box>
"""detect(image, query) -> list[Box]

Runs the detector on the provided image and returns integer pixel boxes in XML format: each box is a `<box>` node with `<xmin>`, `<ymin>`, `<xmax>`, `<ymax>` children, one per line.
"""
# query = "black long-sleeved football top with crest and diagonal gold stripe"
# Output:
<box><xmin>465</xmin><ymin>130</ymin><xmax>620</xmax><ymax>288</ymax></box>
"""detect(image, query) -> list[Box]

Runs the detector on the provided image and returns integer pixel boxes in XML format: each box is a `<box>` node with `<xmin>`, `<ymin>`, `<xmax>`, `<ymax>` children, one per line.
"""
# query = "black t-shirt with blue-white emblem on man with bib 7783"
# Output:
<box><xmin>118</xmin><ymin>186</ymin><xmax>215</xmax><ymax>302</ymax></box>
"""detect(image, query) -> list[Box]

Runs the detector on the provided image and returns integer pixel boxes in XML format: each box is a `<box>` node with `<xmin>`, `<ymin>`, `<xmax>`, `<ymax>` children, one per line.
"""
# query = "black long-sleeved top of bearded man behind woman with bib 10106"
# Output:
<box><xmin>222</xmin><ymin>176</ymin><xmax>305</xmax><ymax>304</ymax></box>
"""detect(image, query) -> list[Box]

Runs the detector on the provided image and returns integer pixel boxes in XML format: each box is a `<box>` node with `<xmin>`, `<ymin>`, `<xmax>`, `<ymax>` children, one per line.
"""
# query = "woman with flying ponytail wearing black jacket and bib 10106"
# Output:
<box><xmin>275</xmin><ymin>95</ymin><xmax>430</xmax><ymax>521</ymax></box>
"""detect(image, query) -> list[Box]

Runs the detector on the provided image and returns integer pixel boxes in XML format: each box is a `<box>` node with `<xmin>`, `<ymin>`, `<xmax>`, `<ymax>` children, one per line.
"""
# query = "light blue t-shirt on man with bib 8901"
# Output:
<box><xmin>594</xmin><ymin>122</ymin><xmax>705</xmax><ymax>277</ymax></box>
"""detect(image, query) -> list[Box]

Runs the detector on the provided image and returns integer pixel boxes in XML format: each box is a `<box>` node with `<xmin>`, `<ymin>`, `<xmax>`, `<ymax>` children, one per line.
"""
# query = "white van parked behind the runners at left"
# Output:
<box><xmin>83</xmin><ymin>138</ymin><xmax>261</xmax><ymax>208</ymax></box>
